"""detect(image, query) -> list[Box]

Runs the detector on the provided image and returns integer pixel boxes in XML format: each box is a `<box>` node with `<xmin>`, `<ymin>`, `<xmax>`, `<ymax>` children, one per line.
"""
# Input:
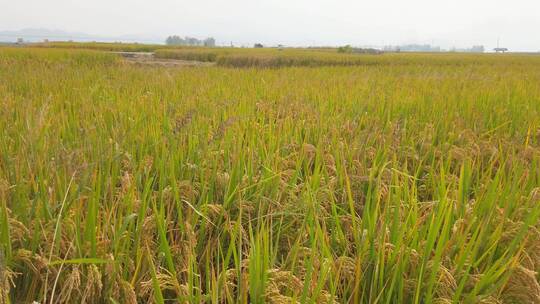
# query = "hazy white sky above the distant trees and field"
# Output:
<box><xmin>0</xmin><ymin>0</ymin><xmax>540</xmax><ymax>51</ymax></box>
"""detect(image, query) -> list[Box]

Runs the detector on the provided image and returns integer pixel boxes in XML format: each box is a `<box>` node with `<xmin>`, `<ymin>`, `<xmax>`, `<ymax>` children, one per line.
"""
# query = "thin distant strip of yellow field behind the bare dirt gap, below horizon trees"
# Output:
<box><xmin>23</xmin><ymin>42</ymin><xmax>540</xmax><ymax>68</ymax></box>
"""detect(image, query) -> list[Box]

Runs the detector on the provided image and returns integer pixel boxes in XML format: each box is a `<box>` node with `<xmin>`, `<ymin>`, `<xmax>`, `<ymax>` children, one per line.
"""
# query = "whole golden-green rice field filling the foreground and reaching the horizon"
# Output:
<box><xmin>0</xmin><ymin>48</ymin><xmax>540</xmax><ymax>304</ymax></box>
